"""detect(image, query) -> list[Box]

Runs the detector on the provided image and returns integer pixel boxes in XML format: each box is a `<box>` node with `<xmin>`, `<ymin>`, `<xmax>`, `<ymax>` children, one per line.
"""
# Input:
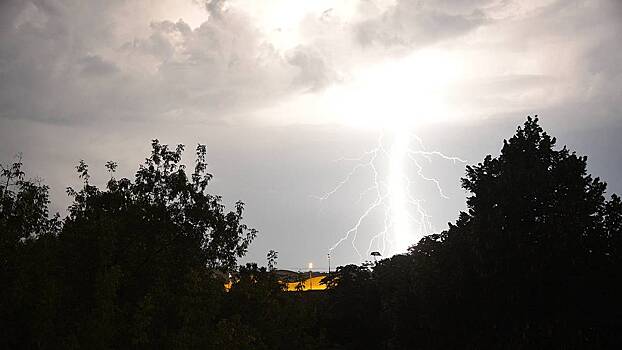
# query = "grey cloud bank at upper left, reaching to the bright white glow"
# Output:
<box><xmin>0</xmin><ymin>0</ymin><xmax>342</xmax><ymax>123</ymax></box>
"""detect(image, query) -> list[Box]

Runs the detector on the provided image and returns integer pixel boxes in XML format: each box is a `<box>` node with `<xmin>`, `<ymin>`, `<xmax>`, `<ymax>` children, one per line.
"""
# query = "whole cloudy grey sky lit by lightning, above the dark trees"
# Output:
<box><xmin>0</xmin><ymin>0</ymin><xmax>622</xmax><ymax>269</ymax></box>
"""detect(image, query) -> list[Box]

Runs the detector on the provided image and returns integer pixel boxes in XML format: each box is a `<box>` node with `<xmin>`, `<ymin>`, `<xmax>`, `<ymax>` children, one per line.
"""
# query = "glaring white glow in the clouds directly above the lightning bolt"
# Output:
<box><xmin>324</xmin><ymin>49</ymin><xmax>464</xmax><ymax>130</ymax></box>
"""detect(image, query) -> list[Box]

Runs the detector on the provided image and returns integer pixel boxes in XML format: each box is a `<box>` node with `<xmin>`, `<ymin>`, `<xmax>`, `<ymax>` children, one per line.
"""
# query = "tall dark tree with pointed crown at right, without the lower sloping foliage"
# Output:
<box><xmin>440</xmin><ymin>118</ymin><xmax>613</xmax><ymax>346</ymax></box>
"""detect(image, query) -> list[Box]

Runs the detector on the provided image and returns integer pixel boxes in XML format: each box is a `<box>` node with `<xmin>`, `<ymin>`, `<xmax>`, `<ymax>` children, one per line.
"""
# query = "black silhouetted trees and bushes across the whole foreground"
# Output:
<box><xmin>0</xmin><ymin>118</ymin><xmax>622</xmax><ymax>349</ymax></box>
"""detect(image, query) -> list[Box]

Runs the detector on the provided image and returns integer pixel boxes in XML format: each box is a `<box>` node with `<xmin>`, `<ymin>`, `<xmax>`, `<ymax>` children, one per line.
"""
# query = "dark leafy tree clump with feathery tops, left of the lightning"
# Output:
<box><xmin>0</xmin><ymin>140</ymin><xmax>256</xmax><ymax>348</ymax></box>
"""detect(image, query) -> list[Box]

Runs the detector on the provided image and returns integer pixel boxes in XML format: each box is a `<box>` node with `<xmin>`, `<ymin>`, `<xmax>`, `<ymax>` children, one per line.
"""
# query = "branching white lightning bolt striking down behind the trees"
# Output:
<box><xmin>314</xmin><ymin>130</ymin><xmax>466</xmax><ymax>261</ymax></box>
